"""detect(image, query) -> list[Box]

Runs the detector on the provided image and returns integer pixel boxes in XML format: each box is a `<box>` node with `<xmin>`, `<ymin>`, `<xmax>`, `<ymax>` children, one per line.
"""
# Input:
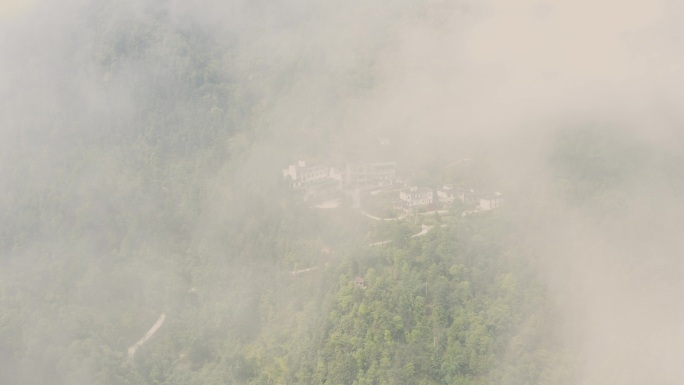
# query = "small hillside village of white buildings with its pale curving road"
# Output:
<box><xmin>282</xmin><ymin>155</ymin><xmax>504</xmax><ymax>216</ymax></box>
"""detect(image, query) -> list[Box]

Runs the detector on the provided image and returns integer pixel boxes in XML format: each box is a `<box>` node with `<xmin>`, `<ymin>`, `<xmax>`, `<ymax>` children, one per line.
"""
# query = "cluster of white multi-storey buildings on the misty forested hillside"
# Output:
<box><xmin>283</xmin><ymin>160</ymin><xmax>503</xmax><ymax>213</ymax></box>
